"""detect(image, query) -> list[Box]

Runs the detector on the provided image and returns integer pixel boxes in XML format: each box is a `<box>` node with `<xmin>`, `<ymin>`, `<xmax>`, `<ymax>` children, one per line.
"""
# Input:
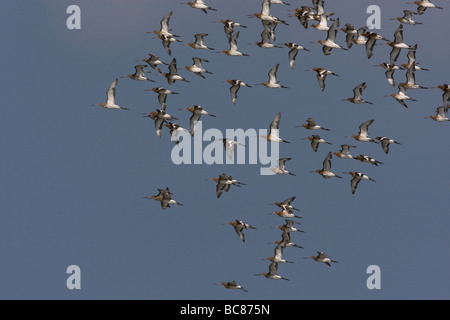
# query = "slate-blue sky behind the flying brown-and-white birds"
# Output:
<box><xmin>0</xmin><ymin>0</ymin><xmax>450</xmax><ymax>299</ymax></box>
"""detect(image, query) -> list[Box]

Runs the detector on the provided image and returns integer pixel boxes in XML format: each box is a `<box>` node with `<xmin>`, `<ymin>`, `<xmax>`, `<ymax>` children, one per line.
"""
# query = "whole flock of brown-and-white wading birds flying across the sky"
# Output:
<box><xmin>91</xmin><ymin>0</ymin><xmax>450</xmax><ymax>291</ymax></box>
